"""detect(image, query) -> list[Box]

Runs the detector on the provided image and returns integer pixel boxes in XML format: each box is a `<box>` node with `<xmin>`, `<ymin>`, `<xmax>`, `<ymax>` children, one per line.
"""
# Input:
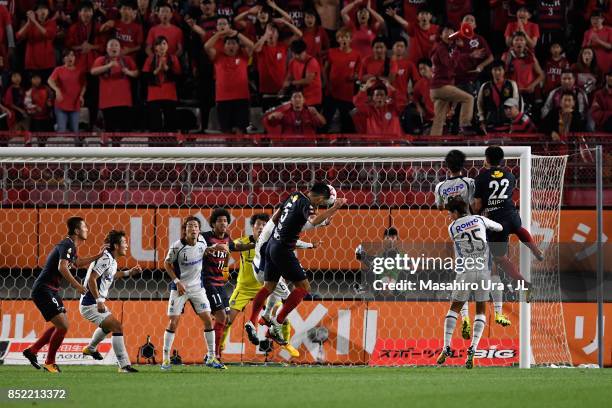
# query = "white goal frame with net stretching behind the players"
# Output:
<box><xmin>0</xmin><ymin>147</ymin><xmax>571</xmax><ymax>366</ymax></box>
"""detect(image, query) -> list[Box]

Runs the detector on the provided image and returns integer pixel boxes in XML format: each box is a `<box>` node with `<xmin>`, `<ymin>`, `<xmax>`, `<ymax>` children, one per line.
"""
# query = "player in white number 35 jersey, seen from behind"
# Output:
<box><xmin>437</xmin><ymin>198</ymin><xmax>503</xmax><ymax>368</ymax></box>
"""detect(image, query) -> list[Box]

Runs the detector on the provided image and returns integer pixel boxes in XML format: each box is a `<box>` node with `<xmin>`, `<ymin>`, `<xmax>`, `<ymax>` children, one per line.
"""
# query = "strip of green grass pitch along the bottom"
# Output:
<box><xmin>0</xmin><ymin>366</ymin><xmax>612</xmax><ymax>408</ymax></box>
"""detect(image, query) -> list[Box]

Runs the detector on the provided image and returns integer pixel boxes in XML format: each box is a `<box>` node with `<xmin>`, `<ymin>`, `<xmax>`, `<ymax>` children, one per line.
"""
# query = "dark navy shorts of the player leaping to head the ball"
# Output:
<box><xmin>264</xmin><ymin>239</ymin><xmax>307</xmax><ymax>282</ymax></box>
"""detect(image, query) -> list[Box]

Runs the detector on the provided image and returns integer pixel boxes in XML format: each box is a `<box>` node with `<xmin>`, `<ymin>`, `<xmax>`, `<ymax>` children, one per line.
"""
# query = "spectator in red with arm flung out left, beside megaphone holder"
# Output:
<box><xmin>387</xmin><ymin>9</ymin><xmax>439</xmax><ymax>64</ymax></box>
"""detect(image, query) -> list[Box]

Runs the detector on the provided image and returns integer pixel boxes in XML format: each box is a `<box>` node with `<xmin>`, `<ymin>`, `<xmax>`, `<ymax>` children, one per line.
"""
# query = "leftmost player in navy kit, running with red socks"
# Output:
<box><xmin>23</xmin><ymin>217</ymin><xmax>104</xmax><ymax>373</ymax></box>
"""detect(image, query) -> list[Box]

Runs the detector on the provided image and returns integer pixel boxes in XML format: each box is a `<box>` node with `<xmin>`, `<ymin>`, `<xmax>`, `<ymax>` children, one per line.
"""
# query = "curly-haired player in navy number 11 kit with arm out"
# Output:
<box><xmin>202</xmin><ymin>208</ymin><xmax>255</xmax><ymax>358</ymax></box>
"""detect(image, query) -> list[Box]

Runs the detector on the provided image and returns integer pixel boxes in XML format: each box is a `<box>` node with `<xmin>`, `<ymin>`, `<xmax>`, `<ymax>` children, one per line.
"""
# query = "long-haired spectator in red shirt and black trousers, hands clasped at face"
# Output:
<box><xmin>142</xmin><ymin>36</ymin><xmax>181</xmax><ymax>132</ymax></box>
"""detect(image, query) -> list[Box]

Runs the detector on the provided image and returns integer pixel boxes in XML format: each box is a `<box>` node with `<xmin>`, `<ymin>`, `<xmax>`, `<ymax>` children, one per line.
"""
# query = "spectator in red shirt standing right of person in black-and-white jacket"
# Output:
<box><xmin>502</xmin><ymin>31</ymin><xmax>544</xmax><ymax>112</ymax></box>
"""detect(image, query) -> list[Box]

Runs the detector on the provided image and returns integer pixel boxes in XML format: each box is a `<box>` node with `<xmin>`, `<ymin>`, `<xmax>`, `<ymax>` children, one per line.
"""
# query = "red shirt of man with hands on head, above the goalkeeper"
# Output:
<box><xmin>213</xmin><ymin>50</ymin><xmax>249</xmax><ymax>102</ymax></box>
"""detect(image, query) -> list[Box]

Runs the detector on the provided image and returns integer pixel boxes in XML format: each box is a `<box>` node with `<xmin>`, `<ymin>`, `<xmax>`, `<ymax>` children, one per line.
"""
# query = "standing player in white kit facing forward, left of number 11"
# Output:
<box><xmin>161</xmin><ymin>216</ymin><xmax>226</xmax><ymax>370</ymax></box>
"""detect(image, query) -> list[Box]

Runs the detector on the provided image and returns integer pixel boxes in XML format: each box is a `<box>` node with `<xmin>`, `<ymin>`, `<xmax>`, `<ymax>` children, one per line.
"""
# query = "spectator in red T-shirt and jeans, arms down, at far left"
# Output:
<box><xmin>48</xmin><ymin>48</ymin><xmax>87</xmax><ymax>133</ymax></box>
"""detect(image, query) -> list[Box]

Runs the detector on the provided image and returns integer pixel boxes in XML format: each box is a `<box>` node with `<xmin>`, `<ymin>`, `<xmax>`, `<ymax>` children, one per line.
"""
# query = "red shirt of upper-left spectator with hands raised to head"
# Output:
<box><xmin>17</xmin><ymin>20</ymin><xmax>57</xmax><ymax>70</ymax></box>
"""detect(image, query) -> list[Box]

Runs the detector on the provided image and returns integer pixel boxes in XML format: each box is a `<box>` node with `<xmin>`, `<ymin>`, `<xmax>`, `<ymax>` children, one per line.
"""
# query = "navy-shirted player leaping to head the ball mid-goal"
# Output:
<box><xmin>245</xmin><ymin>183</ymin><xmax>346</xmax><ymax>346</ymax></box>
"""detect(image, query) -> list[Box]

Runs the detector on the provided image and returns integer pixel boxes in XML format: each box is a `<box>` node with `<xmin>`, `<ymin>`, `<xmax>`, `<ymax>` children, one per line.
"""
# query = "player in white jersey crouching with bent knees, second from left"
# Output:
<box><xmin>79</xmin><ymin>230</ymin><xmax>142</xmax><ymax>373</ymax></box>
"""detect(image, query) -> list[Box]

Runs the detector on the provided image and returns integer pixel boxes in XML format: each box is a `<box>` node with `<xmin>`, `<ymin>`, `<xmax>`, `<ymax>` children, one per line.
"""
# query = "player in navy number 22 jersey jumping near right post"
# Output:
<box><xmin>472</xmin><ymin>146</ymin><xmax>544</xmax><ymax>296</ymax></box>
